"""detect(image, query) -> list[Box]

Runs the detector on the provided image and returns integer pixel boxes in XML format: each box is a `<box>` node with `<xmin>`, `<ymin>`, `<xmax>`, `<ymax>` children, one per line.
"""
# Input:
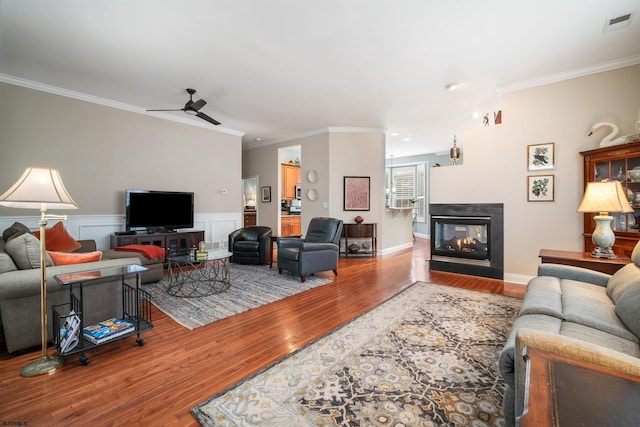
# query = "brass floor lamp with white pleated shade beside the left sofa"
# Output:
<box><xmin>0</xmin><ymin>167</ymin><xmax>78</xmax><ymax>377</ymax></box>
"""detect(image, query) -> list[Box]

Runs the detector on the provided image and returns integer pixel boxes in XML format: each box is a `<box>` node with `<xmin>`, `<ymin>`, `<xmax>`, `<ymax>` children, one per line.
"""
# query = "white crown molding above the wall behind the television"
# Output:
<box><xmin>0</xmin><ymin>74</ymin><xmax>244</xmax><ymax>137</ymax></box>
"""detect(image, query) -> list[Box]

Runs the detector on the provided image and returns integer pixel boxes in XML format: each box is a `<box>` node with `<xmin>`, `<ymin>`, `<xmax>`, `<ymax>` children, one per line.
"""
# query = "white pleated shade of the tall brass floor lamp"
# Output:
<box><xmin>0</xmin><ymin>167</ymin><xmax>78</xmax><ymax>209</ymax></box>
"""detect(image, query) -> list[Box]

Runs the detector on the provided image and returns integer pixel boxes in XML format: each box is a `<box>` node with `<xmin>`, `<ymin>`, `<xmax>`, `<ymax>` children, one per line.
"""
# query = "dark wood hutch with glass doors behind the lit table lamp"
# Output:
<box><xmin>580</xmin><ymin>141</ymin><xmax>640</xmax><ymax>258</ymax></box>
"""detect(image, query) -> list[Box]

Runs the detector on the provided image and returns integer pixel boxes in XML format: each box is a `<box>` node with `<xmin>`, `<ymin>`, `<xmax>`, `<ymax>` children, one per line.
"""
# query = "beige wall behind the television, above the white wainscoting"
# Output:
<box><xmin>0</xmin><ymin>83</ymin><xmax>242</xmax><ymax>216</ymax></box>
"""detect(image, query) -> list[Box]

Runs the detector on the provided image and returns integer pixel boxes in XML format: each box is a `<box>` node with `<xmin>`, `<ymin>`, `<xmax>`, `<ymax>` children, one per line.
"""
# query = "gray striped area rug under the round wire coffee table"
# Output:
<box><xmin>142</xmin><ymin>264</ymin><xmax>331</xmax><ymax>329</ymax></box>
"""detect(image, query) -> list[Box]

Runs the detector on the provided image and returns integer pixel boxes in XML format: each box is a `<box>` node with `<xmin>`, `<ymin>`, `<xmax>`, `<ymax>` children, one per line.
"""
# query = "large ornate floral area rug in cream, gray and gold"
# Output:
<box><xmin>192</xmin><ymin>282</ymin><xmax>521</xmax><ymax>427</ymax></box>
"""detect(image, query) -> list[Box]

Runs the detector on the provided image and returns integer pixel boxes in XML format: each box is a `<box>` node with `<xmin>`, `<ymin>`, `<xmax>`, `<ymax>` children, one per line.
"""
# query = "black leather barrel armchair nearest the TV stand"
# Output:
<box><xmin>229</xmin><ymin>225</ymin><xmax>271</xmax><ymax>265</ymax></box>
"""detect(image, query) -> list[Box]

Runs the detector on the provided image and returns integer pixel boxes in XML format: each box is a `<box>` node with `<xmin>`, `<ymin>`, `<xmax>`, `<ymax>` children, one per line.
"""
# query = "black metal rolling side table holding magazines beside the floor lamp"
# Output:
<box><xmin>51</xmin><ymin>264</ymin><xmax>153</xmax><ymax>366</ymax></box>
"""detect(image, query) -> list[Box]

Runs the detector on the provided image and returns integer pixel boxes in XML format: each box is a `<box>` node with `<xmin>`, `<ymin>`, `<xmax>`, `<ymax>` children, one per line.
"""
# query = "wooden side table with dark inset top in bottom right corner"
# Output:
<box><xmin>516</xmin><ymin>347</ymin><xmax>640</xmax><ymax>427</ymax></box>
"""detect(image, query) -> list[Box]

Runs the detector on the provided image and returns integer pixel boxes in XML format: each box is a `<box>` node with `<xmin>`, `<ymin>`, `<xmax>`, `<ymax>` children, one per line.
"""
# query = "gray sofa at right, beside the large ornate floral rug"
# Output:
<box><xmin>499</xmin><ymin>243</ymin><xmax>640</xmax><ymax>426</ymax></box>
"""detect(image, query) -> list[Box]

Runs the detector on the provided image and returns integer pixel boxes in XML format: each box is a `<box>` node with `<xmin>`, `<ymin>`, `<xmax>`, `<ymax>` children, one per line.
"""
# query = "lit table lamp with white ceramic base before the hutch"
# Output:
<box><xmin>578</xmin><ymin>181</ymin><xmax>633</xmax><ymax>259</ymax></box>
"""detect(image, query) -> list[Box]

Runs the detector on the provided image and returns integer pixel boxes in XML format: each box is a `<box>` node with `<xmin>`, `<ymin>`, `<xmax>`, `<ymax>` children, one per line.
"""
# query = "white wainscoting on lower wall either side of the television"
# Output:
<box><xmin>0</xmin><ymin>212</ymin><xmax>243</xmax><ymax>250</ymax></box>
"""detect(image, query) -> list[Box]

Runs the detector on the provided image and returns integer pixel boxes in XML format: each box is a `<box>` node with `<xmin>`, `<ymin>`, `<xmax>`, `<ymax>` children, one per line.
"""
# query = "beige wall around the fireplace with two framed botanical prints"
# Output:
<box><xmin>430</xmin><ymin>66</ymin><xmax>640</xmax><ymax>280</ymax></box>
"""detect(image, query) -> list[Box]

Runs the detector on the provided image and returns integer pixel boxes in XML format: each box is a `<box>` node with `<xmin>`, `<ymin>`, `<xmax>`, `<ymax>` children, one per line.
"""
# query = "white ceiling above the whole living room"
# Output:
<box><xmin>0</xmin><ymin>0</ymin><xmax>640</xmax><ymax>157</ymax></box>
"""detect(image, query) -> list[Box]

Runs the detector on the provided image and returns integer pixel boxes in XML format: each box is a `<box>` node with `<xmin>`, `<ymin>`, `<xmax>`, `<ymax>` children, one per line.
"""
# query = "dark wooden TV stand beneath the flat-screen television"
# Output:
<box><xmin>111</xmin><ymin>230</ymin><xmax>204</xmax><ymax>256</ymax></box>
